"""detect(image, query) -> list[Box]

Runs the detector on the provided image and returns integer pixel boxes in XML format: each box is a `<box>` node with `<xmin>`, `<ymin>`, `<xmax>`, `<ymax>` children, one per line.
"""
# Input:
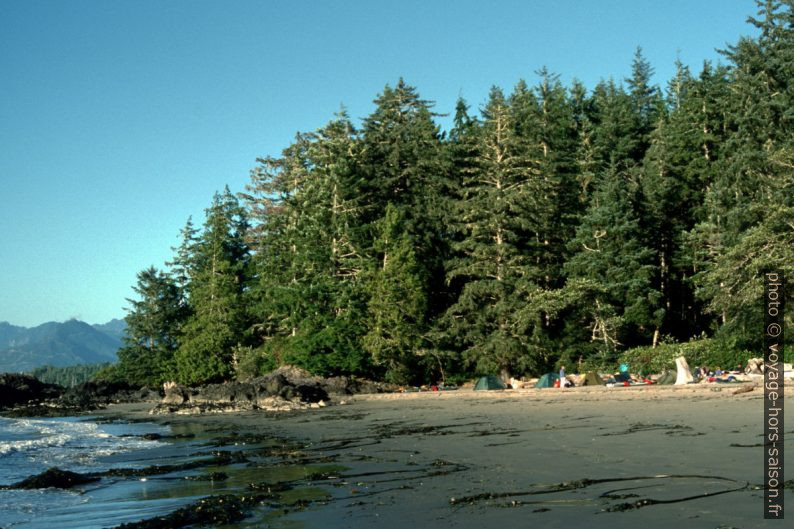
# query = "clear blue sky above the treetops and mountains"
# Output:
<box><xmin>0</xmin><ymin>0</ymin><xmax>756</xmax><ymax>326</ymax></box>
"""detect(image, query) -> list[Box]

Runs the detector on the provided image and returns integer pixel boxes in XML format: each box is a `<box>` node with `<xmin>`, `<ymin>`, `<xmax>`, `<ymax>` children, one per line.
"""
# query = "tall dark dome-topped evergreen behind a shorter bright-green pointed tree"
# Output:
<box><xmin>360</xmin><ymin>79</ymin><xmax>448</xmax><ymax>376</ymax></box>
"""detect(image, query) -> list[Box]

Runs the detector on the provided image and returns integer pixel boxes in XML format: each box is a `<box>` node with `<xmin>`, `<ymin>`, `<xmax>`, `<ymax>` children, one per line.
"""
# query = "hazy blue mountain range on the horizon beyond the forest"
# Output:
<box><xmin>0</xmin><ymin>320</ymin><xmax>126</xmax><ymax>373</ymax></box>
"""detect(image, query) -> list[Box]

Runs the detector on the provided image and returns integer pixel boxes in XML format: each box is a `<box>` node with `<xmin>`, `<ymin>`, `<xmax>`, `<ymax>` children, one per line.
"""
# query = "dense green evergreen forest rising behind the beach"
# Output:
<box><xmin>117</xmin><ymin>1</ymin><xmax>794</xmax><ymax>384</ymax></box>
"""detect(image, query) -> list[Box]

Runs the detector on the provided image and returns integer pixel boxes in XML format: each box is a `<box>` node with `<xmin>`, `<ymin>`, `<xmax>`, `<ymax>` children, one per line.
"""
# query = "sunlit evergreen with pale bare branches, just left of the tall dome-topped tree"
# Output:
<box><xmin>289</xmin><ymin>114</ymin><xmax>370</xmax><ymax>375</ymax></box>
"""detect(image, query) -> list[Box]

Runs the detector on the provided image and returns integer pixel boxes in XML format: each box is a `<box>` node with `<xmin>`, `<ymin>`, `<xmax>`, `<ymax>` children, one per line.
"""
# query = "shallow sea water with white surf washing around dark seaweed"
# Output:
<box><xmin>0</xmin><ymin>417</ymin><xmax>324</xmax><ymax>529</ymax></box>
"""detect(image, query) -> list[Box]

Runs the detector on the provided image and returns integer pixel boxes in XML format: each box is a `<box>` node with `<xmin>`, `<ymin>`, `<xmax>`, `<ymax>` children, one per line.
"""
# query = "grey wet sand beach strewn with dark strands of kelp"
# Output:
<box><xmin>107</xmin><ymin>385</ymin><xmax>794</xmax><ymax>529</ymax></box>
